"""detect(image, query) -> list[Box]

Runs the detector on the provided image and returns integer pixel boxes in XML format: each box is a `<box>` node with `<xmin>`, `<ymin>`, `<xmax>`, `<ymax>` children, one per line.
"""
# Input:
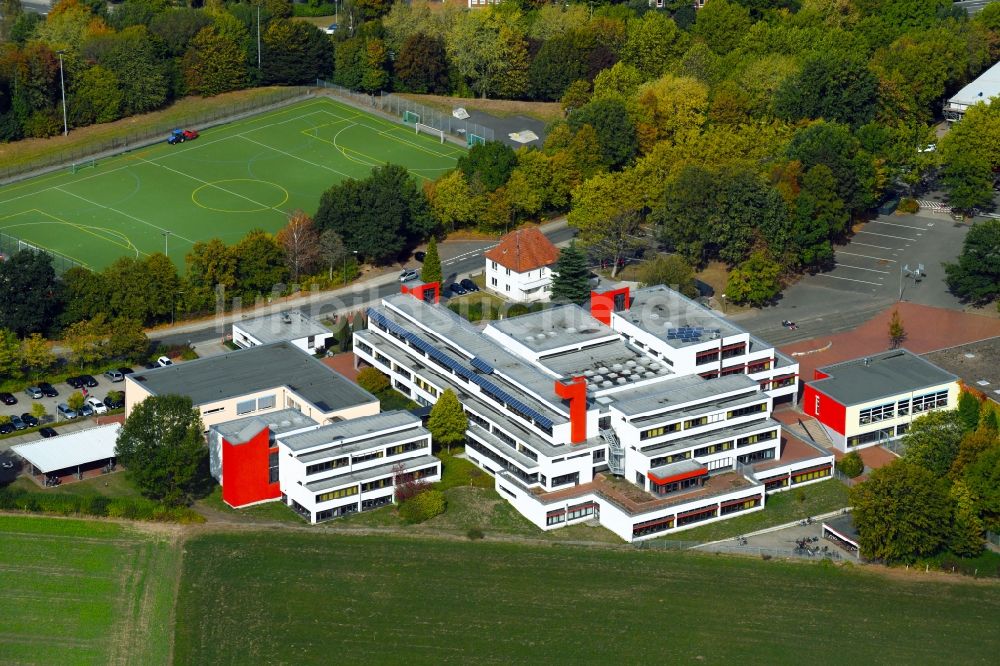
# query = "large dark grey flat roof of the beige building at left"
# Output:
<box><xmin>126</xmin><ymin>341</ymin><xmax>377</xmax><ymax>413</ymax></box>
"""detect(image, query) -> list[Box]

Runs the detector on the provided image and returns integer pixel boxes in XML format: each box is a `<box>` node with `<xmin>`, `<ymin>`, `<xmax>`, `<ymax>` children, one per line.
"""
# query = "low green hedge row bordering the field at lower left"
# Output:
<box><xmin>0</xmin><ymin>488</ymin><xmax>205</xmax><ymax>523</ymax></box>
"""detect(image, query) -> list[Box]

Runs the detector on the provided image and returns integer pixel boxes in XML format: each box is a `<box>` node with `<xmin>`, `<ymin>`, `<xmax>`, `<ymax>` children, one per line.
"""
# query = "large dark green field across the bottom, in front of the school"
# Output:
<box><xmin>175</xmin><ymin>531</ymin><xmax>1000</xmax><ymax>664</ymax></box>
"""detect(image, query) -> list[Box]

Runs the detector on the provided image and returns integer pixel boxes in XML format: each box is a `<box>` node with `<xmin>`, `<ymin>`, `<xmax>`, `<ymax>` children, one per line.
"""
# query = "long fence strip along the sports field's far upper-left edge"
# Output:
<box><xmin>0</xmin><ymin>87</ymin><xmax>311</xmax><ymax>184</ymax></box>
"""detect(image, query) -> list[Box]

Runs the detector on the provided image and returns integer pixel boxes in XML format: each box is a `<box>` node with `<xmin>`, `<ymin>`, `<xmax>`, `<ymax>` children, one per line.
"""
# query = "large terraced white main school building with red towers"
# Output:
<box><xmin>354</xmin><ymin>287</ymin><xmax>833</xmax><ymax>541</ymax></box>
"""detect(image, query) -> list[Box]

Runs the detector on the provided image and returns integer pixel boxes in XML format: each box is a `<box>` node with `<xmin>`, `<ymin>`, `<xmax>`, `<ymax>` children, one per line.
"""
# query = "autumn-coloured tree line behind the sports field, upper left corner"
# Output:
<box><xmin>0</xmin><ymin>0</ymin><xmax>333</xmax><ymax>141</ymax></box>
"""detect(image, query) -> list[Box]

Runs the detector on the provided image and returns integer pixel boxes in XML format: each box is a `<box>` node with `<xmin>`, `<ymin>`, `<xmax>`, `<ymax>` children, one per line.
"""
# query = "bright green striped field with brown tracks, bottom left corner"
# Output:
<box><xmin>0</xmin><ymin>516</ymin><xmax>181</xmax><ymax>666</ymax></box>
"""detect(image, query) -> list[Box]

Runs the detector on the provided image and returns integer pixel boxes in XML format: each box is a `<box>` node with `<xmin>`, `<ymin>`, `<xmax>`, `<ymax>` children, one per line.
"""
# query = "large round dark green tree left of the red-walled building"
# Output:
<box><xmin>115</xmin><ymin>395</ymin><xmax>208</xmax><ymax>505</ymax></box>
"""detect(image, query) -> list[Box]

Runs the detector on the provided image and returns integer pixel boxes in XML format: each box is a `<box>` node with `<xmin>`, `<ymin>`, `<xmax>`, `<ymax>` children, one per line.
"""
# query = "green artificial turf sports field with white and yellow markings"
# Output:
<box><xmin>0</xmin><ymin>97</ymin><xmax>464</xmax><ymax>269</ymax></box>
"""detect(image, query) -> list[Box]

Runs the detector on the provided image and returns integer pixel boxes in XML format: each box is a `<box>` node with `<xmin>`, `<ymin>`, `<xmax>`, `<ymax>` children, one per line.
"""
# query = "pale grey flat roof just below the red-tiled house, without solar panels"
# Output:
<box><xmin>487</xmin><ymin>305</ymin><xmax>619</xmax><ymax>353</ymax></box>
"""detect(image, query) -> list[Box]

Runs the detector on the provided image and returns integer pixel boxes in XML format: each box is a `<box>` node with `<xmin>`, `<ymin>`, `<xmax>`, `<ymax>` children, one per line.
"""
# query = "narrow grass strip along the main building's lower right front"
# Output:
<box><xmin>666</xmin><ymin>479</ymin><xmax>850</xmax><ymax>541</ymax></box>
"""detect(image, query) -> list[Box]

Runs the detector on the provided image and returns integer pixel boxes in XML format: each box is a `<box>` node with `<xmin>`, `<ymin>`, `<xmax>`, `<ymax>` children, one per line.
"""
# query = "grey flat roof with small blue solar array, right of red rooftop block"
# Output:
<box><xmin>615</xmin><ymin>285</ymin><xmax>747</xmax><ymax>349</ymax></box>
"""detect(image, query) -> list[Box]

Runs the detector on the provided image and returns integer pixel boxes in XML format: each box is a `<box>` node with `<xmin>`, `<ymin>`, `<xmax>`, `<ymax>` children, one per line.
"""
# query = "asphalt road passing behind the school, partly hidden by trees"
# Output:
<box><xmin>149</xmin><ymin>224</ymin><xmax>575</xmax><ymax>344</ymax></box>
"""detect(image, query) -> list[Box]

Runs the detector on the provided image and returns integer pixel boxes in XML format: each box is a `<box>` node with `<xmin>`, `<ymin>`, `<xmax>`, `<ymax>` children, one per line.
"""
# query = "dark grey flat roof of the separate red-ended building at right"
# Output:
<box><xmin>809</xmin><ymin>349</ymin><xmax>958</xmax><ymax>405</ymax></box>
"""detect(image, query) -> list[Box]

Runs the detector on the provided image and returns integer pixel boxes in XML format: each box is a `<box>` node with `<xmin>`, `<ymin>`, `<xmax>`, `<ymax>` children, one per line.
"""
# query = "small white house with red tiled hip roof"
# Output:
<box><xmin>486</xmin><ymin>227</ymin><xmax>559</xmax><ymax>303</ymax></box>
